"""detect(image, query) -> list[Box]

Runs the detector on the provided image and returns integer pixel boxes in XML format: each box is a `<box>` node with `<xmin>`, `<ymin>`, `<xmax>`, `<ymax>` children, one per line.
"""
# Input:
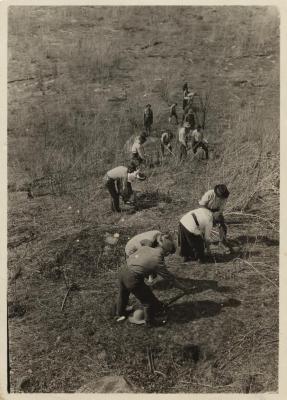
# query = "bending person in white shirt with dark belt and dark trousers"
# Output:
<box><xmin>178</xmin><ymin>208</ymin><xmax>224</xmax><ymax>262</ymax></box>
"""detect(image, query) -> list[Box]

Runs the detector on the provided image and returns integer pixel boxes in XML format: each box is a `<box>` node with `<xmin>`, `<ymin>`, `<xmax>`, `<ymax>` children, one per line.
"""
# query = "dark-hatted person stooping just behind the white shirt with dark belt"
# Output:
<box><xmin>199</xmin><ymin>184</ymin><xmax>229</xmax><ymax>246</ymax></box>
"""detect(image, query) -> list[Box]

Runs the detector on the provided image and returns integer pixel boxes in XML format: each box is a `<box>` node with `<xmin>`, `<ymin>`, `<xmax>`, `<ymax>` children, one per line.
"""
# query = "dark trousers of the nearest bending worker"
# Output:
<box><xmin>117</xmin><ymin>267</ymin><xmax>163</xmax><ymax>321</ymax></box>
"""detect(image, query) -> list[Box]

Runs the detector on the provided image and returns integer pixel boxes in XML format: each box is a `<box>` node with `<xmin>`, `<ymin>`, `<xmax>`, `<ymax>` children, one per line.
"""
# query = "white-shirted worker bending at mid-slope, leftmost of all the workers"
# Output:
<box><xmin>104</xmin><ymin>162</ymin><xmax>145</xmax><ymax>212</ymax></box>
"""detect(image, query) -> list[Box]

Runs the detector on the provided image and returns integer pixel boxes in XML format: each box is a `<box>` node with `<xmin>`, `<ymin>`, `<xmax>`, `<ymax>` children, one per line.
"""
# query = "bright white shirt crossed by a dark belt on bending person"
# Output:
<box><xmin>180</xmin><ymin>208</ymin><xmax>213</xmax><ymax>241</ymax></box>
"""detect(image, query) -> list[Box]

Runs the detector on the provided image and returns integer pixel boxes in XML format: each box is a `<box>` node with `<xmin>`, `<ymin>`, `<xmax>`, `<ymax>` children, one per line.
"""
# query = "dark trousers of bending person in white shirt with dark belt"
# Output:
<box><xmin>178</xmin><ymin>223</ymin><xmax>204</xmax><ymax>261</ymax></box>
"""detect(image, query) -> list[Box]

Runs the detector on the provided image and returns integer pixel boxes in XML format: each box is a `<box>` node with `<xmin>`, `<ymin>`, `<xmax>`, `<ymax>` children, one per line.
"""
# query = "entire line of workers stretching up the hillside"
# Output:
<box><xmin>104</xmin><ymin>84</ymin><xmax>230</xmax><ymax>326</ymax></box>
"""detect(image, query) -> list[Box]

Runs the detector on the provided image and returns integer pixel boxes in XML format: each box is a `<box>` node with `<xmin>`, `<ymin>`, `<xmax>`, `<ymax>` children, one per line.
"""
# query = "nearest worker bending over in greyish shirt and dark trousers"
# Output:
<box><xmin>117</xmin><ymin>239</ymin><xmax>185</xmax><ymax>325</ymax></box>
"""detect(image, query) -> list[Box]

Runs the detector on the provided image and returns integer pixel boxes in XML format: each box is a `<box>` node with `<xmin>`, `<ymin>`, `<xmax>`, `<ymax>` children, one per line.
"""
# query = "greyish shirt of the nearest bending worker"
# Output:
<box><xmin>127</xmin><ymin>246</ymin><xmax>175</xmax><ymax>281</ymax></box>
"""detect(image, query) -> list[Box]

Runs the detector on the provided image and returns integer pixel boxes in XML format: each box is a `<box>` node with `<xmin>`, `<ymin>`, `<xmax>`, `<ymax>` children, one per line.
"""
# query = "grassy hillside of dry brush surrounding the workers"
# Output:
<box><xmin>8</xmin><ymin>6</ymin><xmax>279</xmax><ymax>393</ymax></box>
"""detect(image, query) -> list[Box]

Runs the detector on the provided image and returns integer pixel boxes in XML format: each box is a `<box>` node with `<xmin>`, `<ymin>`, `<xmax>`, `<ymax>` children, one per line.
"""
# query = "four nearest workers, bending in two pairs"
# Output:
<box><xmin>116</xmin><ymin>184</ymin><xmax>229</xmax><ymax>326</ymax></box>
